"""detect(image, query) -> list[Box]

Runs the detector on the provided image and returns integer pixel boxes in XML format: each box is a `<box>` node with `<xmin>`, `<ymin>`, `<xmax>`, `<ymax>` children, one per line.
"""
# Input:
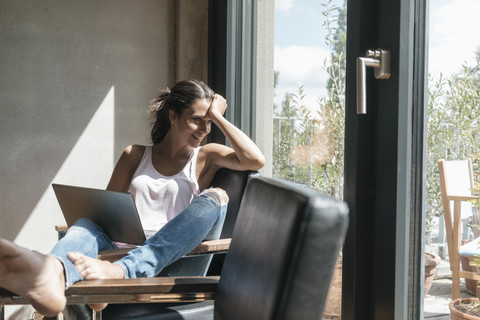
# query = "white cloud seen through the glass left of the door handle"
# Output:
<box><xmin>274</xmin><ymin>45</ymin><xmax>330</xmax><ymax>108</ymax></box>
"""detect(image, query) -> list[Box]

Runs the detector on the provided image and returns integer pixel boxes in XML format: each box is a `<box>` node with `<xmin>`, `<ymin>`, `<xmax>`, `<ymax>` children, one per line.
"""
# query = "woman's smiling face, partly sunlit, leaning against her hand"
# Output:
<box><xmin>173</xmin><ymin>98</ymin><xmax>211</xmax><ymax>147</ymax></box>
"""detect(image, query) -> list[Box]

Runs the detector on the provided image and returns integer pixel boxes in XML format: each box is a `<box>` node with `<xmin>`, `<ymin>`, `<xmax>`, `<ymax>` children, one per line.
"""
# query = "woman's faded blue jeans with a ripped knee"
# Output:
<box><xmin>50</xmin><ymin>190</ymin><xmax>227</xmax><ymax>289</ymax></box>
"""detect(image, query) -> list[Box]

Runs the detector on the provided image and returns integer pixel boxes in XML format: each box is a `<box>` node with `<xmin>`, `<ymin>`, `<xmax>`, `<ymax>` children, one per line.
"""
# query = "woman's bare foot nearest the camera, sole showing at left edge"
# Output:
<box><xmin>0</xmin><ymin>239</ymin><xmax>66</xmax><ymax>317</ymax></box>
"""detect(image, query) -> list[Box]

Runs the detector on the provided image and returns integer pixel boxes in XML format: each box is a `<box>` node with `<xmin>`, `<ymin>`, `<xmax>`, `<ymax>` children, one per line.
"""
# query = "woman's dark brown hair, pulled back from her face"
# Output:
<box><xmin>150</xmin><ymin>79</ymin><xmax>215</xmax><ymax>144</ymax></box>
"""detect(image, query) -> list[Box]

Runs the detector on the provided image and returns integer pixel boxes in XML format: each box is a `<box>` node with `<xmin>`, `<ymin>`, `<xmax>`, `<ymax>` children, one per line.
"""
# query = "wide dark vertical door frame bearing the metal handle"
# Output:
<box><xmin>343</xmin><ymin>0</ymin><xmax>426</xmax><ymax>320</ymax></box>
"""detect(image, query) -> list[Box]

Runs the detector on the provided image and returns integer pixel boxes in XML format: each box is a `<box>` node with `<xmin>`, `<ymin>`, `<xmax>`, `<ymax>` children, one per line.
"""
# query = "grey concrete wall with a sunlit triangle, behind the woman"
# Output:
<box><xmin>0</xmin><ymin>0</ymin><xmax>208</xmax><ymax>319</ymax></box>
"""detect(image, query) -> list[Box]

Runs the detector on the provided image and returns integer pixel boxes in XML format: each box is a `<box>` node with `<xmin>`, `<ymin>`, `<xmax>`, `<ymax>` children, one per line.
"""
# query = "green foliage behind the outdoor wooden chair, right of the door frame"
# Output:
<box><xmin>426</xmin><ymin>61</ymin><xmax>480</xmax><ymax>241</ymax></box>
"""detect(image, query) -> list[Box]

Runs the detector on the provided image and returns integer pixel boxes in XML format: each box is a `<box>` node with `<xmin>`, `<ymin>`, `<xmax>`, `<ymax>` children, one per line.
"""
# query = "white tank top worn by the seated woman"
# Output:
<box><xmin>128</xmin><ymin>146</ymin><xmax>201</xmax><ymax>239</ymax></box>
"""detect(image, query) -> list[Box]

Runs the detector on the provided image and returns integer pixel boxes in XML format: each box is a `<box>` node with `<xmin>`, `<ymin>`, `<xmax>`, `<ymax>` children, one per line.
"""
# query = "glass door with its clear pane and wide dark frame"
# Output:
<box><xmin>273</xmin><ymin>0</ymin><xmax>426</xmax><ymax>319</ymax></box>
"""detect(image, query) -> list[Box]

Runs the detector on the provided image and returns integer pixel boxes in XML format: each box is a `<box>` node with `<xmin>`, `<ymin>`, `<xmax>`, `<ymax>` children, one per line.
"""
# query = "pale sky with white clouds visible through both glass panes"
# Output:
<box><xmin>274</xmin><ymin>0</ymin><xmax>480</xmax><ymax>109</ymax></box>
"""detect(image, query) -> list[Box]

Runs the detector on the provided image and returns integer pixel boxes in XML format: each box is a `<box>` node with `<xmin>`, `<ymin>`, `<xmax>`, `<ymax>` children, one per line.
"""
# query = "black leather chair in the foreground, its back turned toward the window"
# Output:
<box><xmin>103</xmin><ymin>177</ymin><xmax>348</xmax><ymax>320</ymax></box>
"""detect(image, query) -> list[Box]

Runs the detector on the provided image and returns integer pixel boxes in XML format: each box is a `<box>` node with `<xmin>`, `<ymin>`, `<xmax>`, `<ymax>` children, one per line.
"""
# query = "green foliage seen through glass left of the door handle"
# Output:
<box><xmin>273</xmin><ymin>1</ymin><xmax>346</xmax><ymax>199</ymax></box>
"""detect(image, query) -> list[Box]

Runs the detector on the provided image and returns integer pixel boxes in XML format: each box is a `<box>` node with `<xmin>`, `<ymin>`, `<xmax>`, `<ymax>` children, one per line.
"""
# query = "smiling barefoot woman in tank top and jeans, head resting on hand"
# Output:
<box><xmin>0</xmin><ymin>80</ymin><xmax>265</xmax><ymax>315</ymax></box>
